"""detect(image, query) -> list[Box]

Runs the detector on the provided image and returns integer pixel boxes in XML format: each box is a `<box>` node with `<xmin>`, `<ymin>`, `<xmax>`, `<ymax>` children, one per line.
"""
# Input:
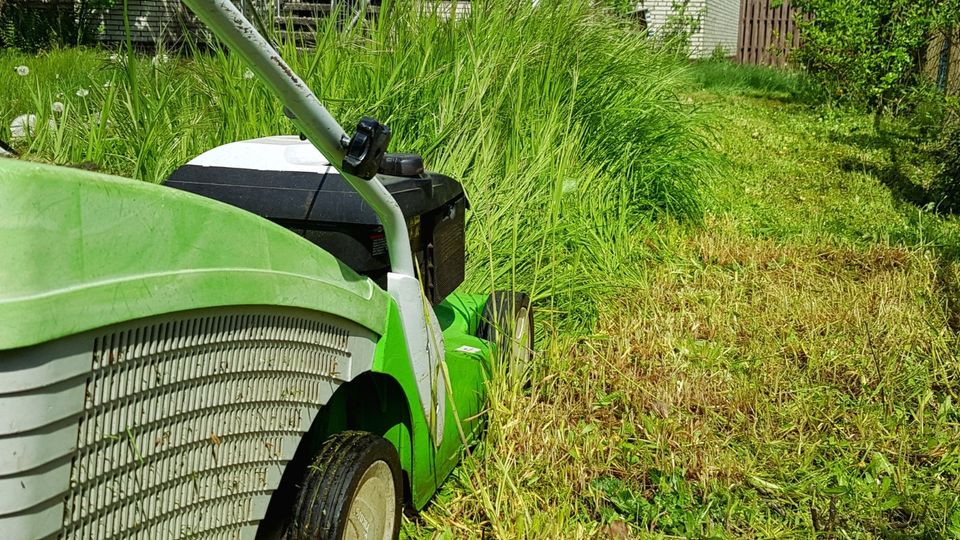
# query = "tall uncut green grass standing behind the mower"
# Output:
<box><xmin>0</xmin><ymin>0</ymin><xmax>711</xmax><ymax>325</ymax></box>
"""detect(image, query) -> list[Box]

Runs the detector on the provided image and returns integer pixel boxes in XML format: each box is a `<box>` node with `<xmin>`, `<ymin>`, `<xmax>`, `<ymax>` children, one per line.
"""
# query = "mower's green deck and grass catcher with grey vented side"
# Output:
<box><xmin>0</xmin><ymin>159</ymin><xmax>494</xmax><ymax>538</ymax></box>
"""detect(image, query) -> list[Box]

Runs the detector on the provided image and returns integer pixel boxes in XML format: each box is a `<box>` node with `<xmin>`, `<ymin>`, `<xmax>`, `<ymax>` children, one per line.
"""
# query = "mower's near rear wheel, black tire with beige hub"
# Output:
<box><xmin>284</xmin><ymin>431</ymin><xmax>403</xmax><ymax>540</ymax></box>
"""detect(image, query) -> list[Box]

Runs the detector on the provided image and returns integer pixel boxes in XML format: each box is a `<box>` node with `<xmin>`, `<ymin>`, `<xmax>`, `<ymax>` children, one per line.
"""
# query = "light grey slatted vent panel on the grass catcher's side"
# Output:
<box><xmin>0</xmin><ymin>309</ymin><xmax>374</xmax><ymax>539</ymax></box>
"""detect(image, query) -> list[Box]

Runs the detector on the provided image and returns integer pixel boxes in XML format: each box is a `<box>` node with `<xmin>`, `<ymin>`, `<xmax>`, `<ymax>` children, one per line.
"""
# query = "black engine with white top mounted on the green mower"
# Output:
<box><xmin>166</xmin><ymin>136</ymin><xmax>467</xmax><ymax>305</ymax></box>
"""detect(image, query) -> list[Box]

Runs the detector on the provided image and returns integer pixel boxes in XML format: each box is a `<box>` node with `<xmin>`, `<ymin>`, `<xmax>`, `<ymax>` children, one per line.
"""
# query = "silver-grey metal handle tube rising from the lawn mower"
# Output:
<box><xmin>184</xmin><ymin>0</ymin><xmax>416</xmax><ymax>277</ymax></box>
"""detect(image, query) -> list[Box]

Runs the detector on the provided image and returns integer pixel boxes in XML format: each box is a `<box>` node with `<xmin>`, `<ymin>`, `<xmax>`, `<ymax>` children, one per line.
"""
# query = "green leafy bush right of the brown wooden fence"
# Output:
<box><xmin>794</xmin><ymin>0</ymin><xmax>960</xmax><ymax>112</ymax></box>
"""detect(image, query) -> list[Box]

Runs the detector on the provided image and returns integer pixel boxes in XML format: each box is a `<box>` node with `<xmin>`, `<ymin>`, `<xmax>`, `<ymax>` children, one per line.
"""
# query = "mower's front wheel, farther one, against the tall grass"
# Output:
<box><xmin>477</xmin><ymin>291</ymin><xmax>533</xmax><ymax>373</ymax></box>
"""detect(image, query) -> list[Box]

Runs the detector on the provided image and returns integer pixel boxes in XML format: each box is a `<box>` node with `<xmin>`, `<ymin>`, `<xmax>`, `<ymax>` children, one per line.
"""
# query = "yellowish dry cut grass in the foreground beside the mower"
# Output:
<box><xmin>412</xmin><ymin>219</ymin><xmax>960</xmax><ymax>538</ymax></box>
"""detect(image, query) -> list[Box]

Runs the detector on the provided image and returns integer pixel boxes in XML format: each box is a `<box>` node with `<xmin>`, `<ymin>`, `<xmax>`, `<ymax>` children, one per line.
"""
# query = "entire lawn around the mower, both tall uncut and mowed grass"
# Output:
<box><xmin>0</xmin><ymin>7</ymin><xmax>960</xmax><ymax>538</ymax></box>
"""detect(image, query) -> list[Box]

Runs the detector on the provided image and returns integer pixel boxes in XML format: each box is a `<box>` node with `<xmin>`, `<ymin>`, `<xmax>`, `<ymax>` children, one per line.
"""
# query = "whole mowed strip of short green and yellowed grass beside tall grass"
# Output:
<box><xmin>407</xmin><ymin>75</ymin><xmax>960</xmax><ymax>538</ymax></box>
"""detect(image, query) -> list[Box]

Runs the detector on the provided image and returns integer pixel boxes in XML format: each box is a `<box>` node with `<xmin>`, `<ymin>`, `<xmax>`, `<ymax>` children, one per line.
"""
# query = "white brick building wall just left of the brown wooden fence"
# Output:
<box><xmin>642</xmin><ymin>0</ymin><xmax>740</xmax><ymax>58</ymax></box>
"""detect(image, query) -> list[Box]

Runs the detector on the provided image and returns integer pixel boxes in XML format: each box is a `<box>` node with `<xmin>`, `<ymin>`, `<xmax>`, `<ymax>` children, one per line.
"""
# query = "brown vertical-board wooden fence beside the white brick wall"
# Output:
<box><xmin>737</xmin><ymin>0</ymin><xmax>800</xmax><ymax>66</ymax></box>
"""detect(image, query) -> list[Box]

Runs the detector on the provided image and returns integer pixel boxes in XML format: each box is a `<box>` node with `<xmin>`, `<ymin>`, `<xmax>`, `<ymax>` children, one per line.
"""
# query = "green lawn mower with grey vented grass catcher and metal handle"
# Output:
<box><xmin>0</xmin><ymin>0</ymin><xmax>533</xmax><ymax>539</ymax></box>
